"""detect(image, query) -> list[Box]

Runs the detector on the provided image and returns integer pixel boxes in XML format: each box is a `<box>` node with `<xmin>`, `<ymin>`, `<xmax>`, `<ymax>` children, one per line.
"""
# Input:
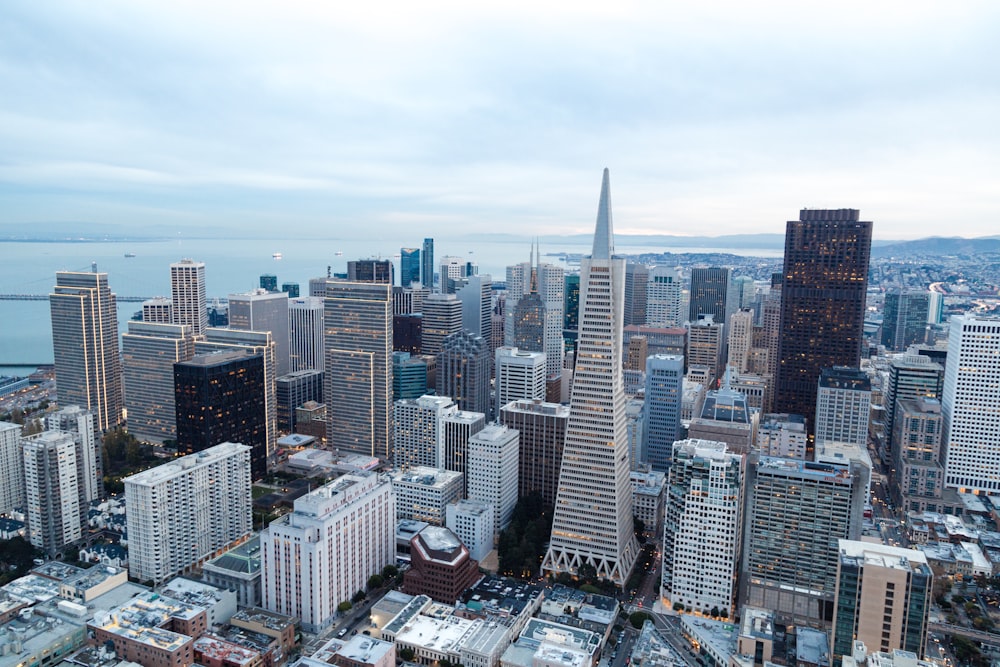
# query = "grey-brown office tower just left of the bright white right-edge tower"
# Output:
<box><xmin>892</xmin><ymin>397</ymin><xmax>944</xmax><ymax>514</ymax></box>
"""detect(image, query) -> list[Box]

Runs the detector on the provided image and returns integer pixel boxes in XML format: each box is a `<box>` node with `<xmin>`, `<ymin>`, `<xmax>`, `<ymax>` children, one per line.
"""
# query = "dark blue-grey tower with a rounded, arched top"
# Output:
<box><xmin>437</xmin><ymin>331</ymin><xmax>493</xmax><ymax>415</ymax></box>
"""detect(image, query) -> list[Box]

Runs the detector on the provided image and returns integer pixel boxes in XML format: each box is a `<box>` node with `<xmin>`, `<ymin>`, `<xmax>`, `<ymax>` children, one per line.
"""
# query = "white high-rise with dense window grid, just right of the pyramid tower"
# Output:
<box><xmin>661</xmin><ymin>439</ymin><xmax>744</xmax><ymax>618</ymax></box>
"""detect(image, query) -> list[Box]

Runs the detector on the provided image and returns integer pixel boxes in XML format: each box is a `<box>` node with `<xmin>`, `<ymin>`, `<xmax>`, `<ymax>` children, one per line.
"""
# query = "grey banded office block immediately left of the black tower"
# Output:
<box><xmin>122</xmin><ymin>322</ymin><xmax>194</xmax><ymax>443</ymax></box>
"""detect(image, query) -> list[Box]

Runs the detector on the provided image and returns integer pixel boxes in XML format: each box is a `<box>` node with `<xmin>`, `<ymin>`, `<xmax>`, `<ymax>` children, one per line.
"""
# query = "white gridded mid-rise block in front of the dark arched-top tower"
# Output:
<box><xmin>392</xmin><ymin>395</ymin><xmax>458</xmax><ymax>470</ymax></box>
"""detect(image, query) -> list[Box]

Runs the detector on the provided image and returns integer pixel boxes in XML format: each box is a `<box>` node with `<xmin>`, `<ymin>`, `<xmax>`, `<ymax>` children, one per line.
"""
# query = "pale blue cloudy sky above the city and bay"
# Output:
<box><xmin>0</xmin><ymin>0</ymin><xmax>1000</xmax><ymax>239</ymax></box>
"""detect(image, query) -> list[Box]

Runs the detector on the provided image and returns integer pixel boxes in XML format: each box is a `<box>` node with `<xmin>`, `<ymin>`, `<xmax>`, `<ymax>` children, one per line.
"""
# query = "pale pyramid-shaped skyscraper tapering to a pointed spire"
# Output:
<box><xmin>542</xmin><ymin>169</ymin><xmax>639</xmax><ymax>584</ymax></box>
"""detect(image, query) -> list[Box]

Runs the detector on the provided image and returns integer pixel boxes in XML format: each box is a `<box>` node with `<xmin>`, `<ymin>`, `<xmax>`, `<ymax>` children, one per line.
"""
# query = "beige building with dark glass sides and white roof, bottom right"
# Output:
<box><xmin>831</xmin><ymin>540</ymin><xmax>934</xmax><ymax>656</ymax></box>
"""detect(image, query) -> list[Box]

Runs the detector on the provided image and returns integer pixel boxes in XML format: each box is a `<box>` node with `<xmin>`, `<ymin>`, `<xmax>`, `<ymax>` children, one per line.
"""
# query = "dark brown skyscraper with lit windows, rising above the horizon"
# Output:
<box><xmin>774</xmin><ymin>208</ymin><xmax>872</xmax><ymax>432</ymax></box>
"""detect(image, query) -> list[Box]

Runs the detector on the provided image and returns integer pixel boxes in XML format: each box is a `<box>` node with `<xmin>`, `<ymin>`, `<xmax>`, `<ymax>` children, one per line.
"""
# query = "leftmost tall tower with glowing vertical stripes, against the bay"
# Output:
<box><xmin>49</xmin><ymin>271</ymin><xmax>124</xmax><ymax>431</ymax></box>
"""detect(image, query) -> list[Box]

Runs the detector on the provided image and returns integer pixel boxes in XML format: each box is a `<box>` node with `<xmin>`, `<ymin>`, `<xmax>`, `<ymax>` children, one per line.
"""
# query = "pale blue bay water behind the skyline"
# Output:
<box><xmin>0</xmin><ymin>238</ymin><xmax>781</xmax><ymax>375</ymax></box>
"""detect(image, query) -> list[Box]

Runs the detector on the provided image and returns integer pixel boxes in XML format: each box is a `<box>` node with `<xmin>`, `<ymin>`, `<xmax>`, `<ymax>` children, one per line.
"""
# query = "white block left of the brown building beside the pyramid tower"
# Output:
<box><xmin>467</xmin><ymin>424</ymin><xmax>520</xmax><ymax>533</ymax></box>
